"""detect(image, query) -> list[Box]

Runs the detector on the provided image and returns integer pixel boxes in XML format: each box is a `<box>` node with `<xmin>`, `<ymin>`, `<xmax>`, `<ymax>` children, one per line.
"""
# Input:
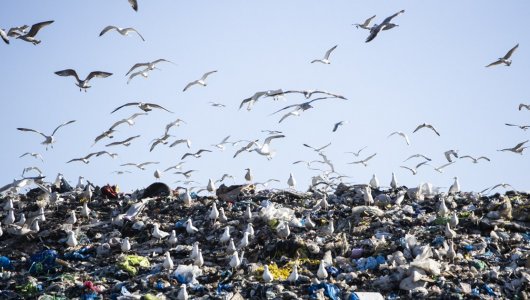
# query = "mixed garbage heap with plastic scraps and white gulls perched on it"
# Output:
<box><xmin>0</xmin><ymin>180</ymin><xmax>530</xmax><ymax>300</ymax></box>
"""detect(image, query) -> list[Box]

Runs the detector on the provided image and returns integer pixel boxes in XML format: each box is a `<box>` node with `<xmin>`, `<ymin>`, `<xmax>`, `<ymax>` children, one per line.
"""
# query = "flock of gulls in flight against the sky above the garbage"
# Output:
<box><xmin>4</xmin><ymin>1</ymin><xmax>530</xmax><ymax>197</ymax></box>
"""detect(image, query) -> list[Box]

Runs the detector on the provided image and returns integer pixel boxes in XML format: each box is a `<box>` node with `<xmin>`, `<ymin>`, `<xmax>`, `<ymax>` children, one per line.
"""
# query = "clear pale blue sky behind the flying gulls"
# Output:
<box><xmin>0</xmin><ymin>0</ymin><xmax>530</xmax><ymax>191</ymax></box>
